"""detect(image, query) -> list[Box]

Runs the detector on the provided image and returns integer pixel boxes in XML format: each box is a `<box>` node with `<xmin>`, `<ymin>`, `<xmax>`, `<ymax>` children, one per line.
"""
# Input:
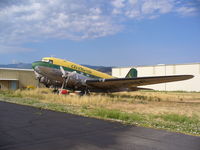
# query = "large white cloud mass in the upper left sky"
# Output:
<box><xmin>0</xmin><ymin>0</ymin><xmax>120</xmax><ymax>43</ymax></box>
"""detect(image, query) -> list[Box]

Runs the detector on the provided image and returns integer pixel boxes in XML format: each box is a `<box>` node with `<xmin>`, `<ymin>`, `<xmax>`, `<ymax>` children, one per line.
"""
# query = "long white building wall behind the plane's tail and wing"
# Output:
<box><xmin>112</xmin><ymin>63</ymin><xmax>200</xmax><ymax>91</ymax></box>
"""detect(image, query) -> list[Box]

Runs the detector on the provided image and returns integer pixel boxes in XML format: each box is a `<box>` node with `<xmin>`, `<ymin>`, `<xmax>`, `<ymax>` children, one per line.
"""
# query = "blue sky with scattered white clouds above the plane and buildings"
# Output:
<box><xmin>0</xmin><ymin>0</ymin><xmax>200</xmax><ymax>67</ymax></box>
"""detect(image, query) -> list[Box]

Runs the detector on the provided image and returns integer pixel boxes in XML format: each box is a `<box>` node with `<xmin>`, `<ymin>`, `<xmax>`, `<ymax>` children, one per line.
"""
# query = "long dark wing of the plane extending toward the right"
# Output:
<box><xmin>86</xmin><ymin>75</ymin><xmax>194</xmax><ymax>91</ymax></box>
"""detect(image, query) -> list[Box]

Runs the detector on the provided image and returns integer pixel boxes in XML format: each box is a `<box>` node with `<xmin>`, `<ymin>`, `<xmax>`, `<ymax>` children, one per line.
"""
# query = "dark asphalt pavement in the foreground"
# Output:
<box><xmin>0</xmin><ymin>102</ymin><xmax>200</xmax><ymax>150</ymax></box>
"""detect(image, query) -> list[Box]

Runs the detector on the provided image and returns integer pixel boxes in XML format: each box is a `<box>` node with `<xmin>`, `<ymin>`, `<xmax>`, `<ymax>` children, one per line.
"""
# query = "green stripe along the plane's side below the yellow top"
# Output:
<box><xmin>32</xmin><ymin>61</ymin><xmax>100</xmax><ymax>79</ymax></box>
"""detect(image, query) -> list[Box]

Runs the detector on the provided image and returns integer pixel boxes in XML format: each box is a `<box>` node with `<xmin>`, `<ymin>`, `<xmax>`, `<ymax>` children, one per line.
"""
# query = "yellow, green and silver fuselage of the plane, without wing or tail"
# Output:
<box><xmin>32</xmin><ymin>57</ymin><xmax>113</xmax><ymax>89</ymax></box>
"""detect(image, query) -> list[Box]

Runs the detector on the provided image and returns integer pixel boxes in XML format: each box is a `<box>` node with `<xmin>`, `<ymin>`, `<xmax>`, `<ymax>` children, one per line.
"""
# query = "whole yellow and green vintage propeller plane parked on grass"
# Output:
<box><xmin>32</xmin><ymin>57</ymin><xmax>193</xmax><ymax>95</ymax></box>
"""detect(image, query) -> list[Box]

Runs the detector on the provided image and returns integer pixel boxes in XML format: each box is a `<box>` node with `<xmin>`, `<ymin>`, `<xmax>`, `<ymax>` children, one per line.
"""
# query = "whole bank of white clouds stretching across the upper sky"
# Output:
<box><xmin>0</xmin><ymin>0</ymin><xmax>199</xmax><ymax>51</ymax></box>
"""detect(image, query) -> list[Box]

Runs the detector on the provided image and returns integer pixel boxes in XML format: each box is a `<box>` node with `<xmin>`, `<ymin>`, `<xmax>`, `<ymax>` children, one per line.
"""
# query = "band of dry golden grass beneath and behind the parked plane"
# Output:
<box><xmin>14</xmin><ymin>89</ymin><xmax>200</xmax><ymax>118</ymax></box>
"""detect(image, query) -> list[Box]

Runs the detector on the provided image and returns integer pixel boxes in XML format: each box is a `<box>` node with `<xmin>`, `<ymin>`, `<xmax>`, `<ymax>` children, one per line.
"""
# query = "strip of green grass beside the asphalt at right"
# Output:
<box><xmin>82</xmin><ymin>108</ymin><xmax>200</xmax><ymax>135</ymax></box>
